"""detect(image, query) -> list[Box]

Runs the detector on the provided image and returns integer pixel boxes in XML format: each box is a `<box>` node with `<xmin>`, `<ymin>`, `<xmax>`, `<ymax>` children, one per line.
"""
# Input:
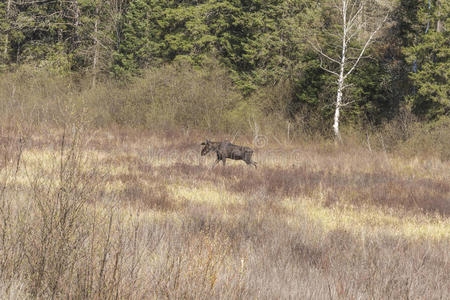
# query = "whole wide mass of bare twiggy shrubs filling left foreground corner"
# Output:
<box><xmin>0</xmin><ymin>126</ymin><xmax>121</xmax><ymax>298</ymax></box>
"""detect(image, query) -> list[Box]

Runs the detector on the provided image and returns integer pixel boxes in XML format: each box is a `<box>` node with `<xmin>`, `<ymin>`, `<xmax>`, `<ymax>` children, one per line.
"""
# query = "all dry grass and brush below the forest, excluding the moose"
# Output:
<box><xmin>0</xmin><ymin>65</ymin><xmax>450</xmax><ymax>299</ymax></box>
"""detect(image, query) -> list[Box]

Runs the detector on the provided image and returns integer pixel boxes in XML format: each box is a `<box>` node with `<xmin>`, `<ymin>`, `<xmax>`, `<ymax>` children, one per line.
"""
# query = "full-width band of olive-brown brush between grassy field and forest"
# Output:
<box><xmin>0</xmin><ymin>61</ymin><xmax>450</xmax><ymax>160</ymax></box>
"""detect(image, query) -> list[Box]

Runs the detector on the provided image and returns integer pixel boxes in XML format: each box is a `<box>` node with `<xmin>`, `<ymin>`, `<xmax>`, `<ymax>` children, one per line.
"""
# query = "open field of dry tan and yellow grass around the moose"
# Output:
<box><xmin>0</xmin><ymin>128</ymin><xmax>450</xmax><ymax>299</ymax></box>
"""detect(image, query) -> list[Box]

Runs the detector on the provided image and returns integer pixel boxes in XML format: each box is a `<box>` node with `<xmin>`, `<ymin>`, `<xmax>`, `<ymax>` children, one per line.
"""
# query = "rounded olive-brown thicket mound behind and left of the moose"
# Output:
<box><xmin>105</xmin><ymin>60</ymin><xmax>241</xmax><ymax>131</ymax></box>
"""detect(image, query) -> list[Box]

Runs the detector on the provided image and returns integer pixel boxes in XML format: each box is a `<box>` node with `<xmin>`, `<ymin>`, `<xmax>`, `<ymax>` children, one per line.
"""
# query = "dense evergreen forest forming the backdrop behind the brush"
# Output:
<box><xmin>0</xmin><ymin>0</ymin><xmax>450</xmax><ymax>138</ymax></box>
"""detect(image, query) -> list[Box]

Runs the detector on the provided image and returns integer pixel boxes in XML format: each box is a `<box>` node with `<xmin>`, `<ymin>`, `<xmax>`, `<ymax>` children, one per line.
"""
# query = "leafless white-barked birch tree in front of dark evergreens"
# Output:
<box><xmin>309</xmin><ymin>0</ymin><xmax>389</xmax><ymax>142</ymax></box>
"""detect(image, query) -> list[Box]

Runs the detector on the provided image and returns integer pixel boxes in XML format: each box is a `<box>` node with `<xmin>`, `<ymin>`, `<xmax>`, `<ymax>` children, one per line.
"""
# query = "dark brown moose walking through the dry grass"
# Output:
<box><xmin>201</xmin><ymin>140</ymin><xmax>256</xmax><ymax>168</ymax></box>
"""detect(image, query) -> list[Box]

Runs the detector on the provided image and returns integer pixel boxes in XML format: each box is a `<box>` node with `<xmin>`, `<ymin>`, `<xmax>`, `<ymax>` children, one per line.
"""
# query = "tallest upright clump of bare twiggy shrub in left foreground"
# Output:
<box><xmin>21</xmin><ymin>128</ymin><xmax>103</xmax><ymax>297</ymax></box>
